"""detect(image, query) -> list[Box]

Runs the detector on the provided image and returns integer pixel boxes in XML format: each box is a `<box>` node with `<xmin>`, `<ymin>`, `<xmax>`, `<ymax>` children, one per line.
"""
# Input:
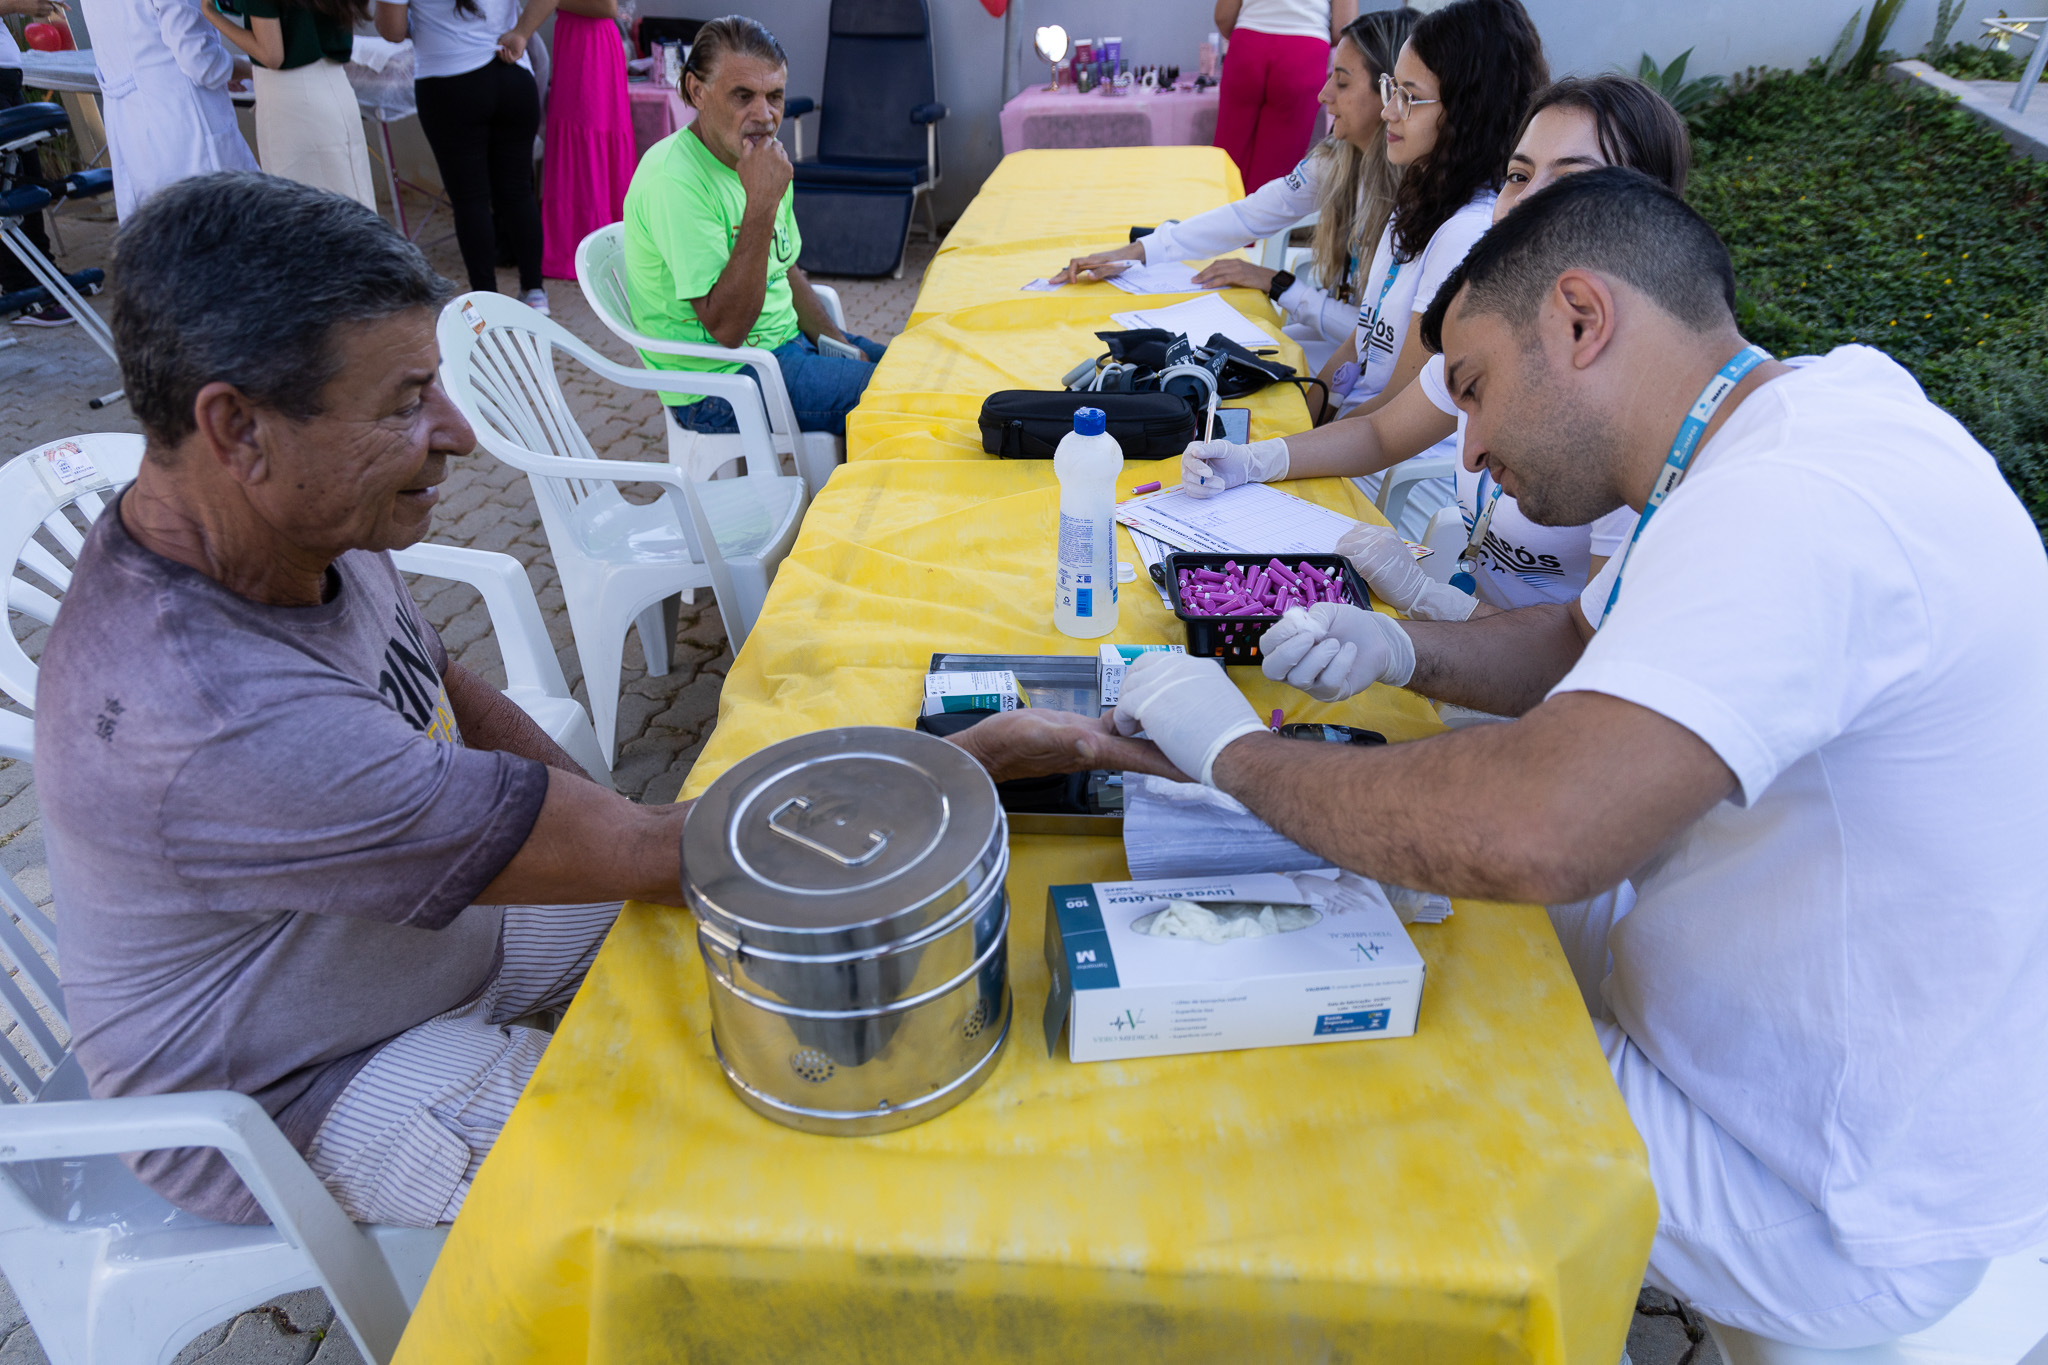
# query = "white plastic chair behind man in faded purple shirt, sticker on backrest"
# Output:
<box><xmin>0</xmin><ymin>432</ymin><xmax>612</xmax><ymax>786</ymax></box>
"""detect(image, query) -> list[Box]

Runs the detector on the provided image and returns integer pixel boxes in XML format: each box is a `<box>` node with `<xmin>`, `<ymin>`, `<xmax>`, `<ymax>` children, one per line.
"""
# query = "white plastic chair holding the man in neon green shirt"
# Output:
<box><xmin>575</xmin><ymin>223</ymin><xmax>846</xmax><ymax>495</ymax></box>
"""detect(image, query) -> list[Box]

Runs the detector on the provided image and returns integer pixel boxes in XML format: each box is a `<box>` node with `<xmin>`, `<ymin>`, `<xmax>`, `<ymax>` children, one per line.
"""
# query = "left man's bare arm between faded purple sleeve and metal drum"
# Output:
<box><xmin>477</xmin><ymin>767</ymin><xmax>690</xmax><ymax>905</ymax></box>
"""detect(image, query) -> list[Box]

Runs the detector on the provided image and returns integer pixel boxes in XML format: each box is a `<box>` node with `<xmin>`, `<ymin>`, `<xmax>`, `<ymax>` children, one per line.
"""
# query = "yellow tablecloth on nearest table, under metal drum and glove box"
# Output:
<box><xmin>397</xmin><ymin>460</ymin><xmax>1657</xmax><ymax>1365</ymax></box>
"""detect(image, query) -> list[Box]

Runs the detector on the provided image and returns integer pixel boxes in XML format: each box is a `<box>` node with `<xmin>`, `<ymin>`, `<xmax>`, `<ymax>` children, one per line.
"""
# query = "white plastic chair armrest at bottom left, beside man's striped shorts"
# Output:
<box><xmin>0</xmin><ymin>1091</ymin><xmax>412</xmax><ymax>1361</ymax></box>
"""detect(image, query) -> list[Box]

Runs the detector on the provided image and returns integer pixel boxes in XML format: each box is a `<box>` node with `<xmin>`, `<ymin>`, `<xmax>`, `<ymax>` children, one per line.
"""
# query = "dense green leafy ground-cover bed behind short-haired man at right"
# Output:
<box><xmin>1688</xmin><ymin>72</ymin><xmax>2048</xmax><ymax>532</ymax></box>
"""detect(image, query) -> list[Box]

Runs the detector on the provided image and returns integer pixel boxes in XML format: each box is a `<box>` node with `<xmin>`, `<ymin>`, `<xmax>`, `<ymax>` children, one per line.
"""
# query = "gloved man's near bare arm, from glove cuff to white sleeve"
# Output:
<box><xmin>1214</xmin><ymin>692</ymin><xmax>1735</xmax><ymax>902</ymax></box>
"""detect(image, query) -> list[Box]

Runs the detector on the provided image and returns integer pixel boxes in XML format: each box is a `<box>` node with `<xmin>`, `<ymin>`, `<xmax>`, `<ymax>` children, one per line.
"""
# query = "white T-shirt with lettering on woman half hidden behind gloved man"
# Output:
<box><xmin>1417</xmin><ymin>356</ymin><xmax>1636</xmax><ymax>612</ymax></box>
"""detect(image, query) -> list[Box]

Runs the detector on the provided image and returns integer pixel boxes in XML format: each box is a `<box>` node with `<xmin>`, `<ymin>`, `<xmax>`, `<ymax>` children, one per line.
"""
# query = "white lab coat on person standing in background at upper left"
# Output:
<box><xmin>84</xmin><ymin>0</ymin><xmax>256</xmax><ymax>217</ymax></box>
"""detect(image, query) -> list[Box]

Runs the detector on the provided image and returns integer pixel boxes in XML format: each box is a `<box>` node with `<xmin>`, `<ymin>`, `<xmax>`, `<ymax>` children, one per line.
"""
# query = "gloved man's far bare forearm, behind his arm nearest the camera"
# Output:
<box><xmin>1401</xmin><ymin>604</ymin><xmax>1585</xmax><ymax>716</ymax></box>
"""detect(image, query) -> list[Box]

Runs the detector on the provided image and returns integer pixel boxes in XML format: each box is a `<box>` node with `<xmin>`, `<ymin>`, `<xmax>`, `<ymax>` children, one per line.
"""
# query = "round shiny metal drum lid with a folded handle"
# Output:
<box><xmin>682</xmin><ymin>726</ymin><xmax>1006</xmax><ymax>954</ymax></box>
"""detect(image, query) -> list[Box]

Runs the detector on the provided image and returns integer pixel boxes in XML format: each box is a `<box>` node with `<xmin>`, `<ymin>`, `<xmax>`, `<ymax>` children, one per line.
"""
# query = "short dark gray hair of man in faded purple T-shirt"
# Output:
<box><xmin>113</xmin><ymin>170</ymin><xmax>455</xmax><ymax>448</ymax></box>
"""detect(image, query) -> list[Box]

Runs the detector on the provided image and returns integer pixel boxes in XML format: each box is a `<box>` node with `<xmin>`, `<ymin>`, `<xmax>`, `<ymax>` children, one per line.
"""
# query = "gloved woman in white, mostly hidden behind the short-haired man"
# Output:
<box><xmin>1182</xmin><ymin>76</ymin><xmax>1692</xmax><ymax>620</ymax></box>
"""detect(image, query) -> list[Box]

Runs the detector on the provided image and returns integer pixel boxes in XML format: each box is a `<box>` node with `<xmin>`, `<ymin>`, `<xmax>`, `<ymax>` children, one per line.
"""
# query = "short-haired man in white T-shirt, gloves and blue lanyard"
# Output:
<box><xmin>1114</xmin><ymin>168</ymin><xmax>2048</xmax><ymax>1349</ymax></box>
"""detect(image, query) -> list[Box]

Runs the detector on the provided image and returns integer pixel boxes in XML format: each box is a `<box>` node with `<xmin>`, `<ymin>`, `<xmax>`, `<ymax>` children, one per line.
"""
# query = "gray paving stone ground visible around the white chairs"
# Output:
<box><xmin>0</xmin><ymin>211</ymin><xmax>1720</xmax><ymax>1365</ymax></box>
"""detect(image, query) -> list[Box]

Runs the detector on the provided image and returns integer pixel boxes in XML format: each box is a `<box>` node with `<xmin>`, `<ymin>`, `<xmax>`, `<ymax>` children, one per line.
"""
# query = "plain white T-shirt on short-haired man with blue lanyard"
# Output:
<box><xmin>1556</xmin><ymin>346</ymin><xmax>2048</xmax><ymax>1267</ymax></box>
